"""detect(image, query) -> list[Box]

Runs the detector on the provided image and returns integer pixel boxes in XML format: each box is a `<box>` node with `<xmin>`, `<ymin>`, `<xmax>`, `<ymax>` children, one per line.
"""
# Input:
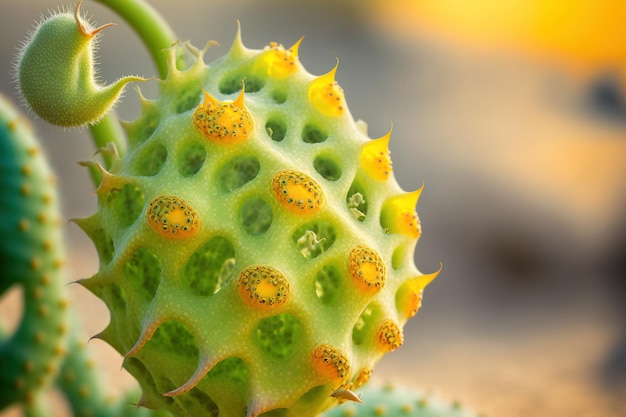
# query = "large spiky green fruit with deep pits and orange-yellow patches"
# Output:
<box><xmin>78</xmin><ymin>28</ymin><xmax>436</xmax><ymax>417</ymax></box>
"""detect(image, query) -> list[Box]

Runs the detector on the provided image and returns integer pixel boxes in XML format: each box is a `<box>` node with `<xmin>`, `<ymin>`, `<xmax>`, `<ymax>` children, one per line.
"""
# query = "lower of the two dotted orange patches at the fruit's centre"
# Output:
<box><xmin>239</xmin><ymin>265</ymin><xmax>290</xmax><ymax>310</ymax></box>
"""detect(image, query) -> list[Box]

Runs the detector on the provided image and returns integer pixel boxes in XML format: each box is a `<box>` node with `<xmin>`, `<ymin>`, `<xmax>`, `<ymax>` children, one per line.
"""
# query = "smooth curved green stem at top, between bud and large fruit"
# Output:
<box><xmin>96</xmin><ymin>0</ymin><xmax>176</xmax><ymax>78</ymax></box>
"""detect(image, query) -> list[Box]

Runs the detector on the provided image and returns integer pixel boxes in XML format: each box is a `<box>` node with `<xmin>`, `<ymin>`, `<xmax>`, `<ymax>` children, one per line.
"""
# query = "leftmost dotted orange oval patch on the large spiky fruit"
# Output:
<box><xmin>146</xmin><ymin>196</ymin><xmax>200</xmax><ymax>239</ymax></box>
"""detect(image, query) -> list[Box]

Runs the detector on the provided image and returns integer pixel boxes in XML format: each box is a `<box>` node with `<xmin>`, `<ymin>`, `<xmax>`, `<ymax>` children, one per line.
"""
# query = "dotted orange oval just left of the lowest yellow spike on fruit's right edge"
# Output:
<box><xmin>348</xmin><ymin>245</ymin><xmax>387</xmax><ymax>295</ymax></box>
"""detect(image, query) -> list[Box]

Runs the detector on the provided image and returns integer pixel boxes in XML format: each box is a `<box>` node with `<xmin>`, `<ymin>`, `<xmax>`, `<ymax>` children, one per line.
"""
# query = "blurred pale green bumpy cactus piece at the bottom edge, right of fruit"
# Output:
<box><xmin>319</xmin><ymin>385</ymin><xmax>479</xmax><ymax>417</ymax></box>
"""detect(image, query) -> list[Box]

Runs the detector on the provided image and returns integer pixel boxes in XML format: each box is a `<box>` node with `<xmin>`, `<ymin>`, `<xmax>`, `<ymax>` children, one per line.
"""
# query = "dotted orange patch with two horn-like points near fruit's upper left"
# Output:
<box><xmin>193</xmin><ymin>88</ymin><xmax>254</xmax><ymax>145</ymax></box>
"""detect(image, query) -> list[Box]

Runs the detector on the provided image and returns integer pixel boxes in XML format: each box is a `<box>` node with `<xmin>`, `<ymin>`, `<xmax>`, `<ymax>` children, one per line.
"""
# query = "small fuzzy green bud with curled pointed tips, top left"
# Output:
<box><xmin>16</xmin><ymin>2</ymin><xmax>146</xmax><ymax>127</ymax></box>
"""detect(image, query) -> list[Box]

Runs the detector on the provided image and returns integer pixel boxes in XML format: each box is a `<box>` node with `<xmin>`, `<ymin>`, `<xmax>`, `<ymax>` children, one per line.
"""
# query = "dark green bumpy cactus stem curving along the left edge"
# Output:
<box><xmin>0</xmin><ymin>97</ymin><xmax>67</xmax><ymax>410</ymax></box>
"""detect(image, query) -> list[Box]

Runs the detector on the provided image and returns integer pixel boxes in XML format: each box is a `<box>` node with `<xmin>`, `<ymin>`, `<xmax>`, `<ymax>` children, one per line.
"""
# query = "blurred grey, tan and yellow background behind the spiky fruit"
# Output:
<box><xmin>0</xmin><ymin>0</ymin><xmax>626</xmax><ymax>417</ymax></box>
